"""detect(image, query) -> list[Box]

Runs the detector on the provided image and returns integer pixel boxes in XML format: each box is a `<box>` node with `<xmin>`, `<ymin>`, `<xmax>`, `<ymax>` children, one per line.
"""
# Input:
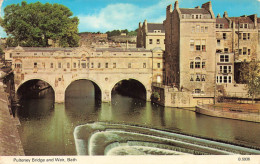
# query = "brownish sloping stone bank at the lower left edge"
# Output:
<box><xmin>0</xmin><ymin>82</ymin><xmax>25</xmax><ymax>156</ymax></box>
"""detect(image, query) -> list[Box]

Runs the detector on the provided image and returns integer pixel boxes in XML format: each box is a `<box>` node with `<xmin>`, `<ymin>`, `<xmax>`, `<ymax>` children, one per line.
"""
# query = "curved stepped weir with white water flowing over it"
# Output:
<box><xmin>74</xmin><ymin>122</ymin><xmax>260</xmax><ymax>155</ymax></box>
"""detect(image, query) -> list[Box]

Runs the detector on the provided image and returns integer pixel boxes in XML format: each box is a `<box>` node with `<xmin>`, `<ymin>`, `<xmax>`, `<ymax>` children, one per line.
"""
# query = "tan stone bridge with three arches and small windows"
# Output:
<box><xmin>5</xmin><ymin>47</ymin><xmax>163</xmax><ymax>102</ymax></box>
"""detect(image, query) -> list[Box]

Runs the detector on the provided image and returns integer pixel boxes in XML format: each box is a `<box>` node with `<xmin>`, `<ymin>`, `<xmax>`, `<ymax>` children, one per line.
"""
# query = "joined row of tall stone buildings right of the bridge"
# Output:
<box><xmin>164</xmin><ymin>1</ymin><xmax>260</xmax><ymax>94</ymax></box>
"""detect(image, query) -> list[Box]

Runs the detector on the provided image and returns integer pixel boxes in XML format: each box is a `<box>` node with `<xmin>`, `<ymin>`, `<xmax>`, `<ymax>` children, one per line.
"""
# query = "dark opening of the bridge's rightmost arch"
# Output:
<box><xmin>111</xmin><ymin>78</ymin><xmax>149</xmax><ymax>100</ymax></box>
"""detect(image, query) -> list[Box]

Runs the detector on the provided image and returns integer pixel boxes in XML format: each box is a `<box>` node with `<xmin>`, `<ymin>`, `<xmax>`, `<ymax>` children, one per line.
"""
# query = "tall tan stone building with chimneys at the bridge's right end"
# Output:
<box><xmin>164</xmin><ymin>1</ymin><xmax>216</xmax><ymax>94</ymax></box>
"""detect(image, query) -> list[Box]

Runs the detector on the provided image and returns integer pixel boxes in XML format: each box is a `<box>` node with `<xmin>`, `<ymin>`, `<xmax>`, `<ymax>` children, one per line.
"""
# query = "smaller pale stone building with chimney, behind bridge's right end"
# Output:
<box><xmin>136</xmin><ymin>20</ymin><xmax>165</xmax><ymax>50</ymax></box>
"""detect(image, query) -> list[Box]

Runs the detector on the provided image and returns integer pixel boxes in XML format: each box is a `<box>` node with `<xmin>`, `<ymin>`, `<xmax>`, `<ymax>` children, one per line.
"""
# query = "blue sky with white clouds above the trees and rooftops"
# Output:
<box><xmin>0</xmin><ymin>0</ymin><xmax>260</xmax><ymax>37</ymax></box>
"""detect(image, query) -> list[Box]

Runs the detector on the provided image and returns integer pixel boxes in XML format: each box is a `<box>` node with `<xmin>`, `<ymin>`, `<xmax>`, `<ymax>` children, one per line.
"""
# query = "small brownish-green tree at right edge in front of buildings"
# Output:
<box><xmin>240</xmin><ymin>61</ymin><xmax>260</xmax><ymax>102</ymax></box>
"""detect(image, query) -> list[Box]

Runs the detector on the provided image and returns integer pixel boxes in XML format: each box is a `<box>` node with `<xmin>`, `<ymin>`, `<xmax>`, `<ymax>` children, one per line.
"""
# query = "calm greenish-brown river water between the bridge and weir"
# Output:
<box><xmin>17</xmin><ymin>81</ymin><xmax>260</xmax><ymax>155</ymax></box>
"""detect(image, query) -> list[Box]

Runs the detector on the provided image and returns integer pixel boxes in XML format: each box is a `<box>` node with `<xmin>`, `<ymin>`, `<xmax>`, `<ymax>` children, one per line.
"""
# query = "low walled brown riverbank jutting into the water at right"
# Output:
<box><xmin>196</xmin><ymin>103</ymin><xmax>260</xmax><ymax>123</ymax></box>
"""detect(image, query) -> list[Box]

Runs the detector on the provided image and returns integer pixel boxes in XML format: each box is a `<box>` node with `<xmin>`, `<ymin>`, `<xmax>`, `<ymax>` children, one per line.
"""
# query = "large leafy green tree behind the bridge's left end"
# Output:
<box><xmin>0</xmin><ymin>1</ymin><xmax>79</xmax><ymax>47</ymax></box>
